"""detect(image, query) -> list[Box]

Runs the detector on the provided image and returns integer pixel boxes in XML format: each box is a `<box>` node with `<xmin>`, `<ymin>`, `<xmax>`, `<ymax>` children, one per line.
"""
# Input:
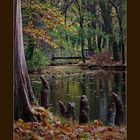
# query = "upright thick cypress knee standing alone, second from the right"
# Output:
<box><xmin>79</xmin><ymin>95</ymin><xmax>89</xmax><ymax>124</ymax></box>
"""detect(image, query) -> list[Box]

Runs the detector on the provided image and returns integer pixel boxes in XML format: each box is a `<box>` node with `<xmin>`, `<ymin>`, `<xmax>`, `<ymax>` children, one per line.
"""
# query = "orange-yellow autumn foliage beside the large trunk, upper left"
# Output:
<box><xmin>22</xmin><ymin>0</ymin><xmax>64</xmax><ymax>47</ymax></box>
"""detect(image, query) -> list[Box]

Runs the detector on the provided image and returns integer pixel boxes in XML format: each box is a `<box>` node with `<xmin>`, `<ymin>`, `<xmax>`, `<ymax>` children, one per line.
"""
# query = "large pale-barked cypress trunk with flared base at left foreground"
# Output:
<box><xmin>14</xmin><ymin>0</ymin><xmax>37</xmax><ymax>121</ymax></box>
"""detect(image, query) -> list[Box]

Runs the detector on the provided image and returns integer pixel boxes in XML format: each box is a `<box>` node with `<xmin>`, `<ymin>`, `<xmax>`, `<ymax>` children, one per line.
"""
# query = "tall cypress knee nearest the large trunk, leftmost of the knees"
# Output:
<box><xmin>40</xmin><ymin>76</ymin><xmax>50</xmax><ymax>109</ymax></box>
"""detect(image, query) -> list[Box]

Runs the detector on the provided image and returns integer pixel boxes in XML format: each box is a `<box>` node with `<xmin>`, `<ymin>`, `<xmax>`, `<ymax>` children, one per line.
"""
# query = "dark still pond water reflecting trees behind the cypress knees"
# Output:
<box><xmin>32</xmin><ymin>70</ymin><xmax>126</xmax><ymax>125</ymax></box>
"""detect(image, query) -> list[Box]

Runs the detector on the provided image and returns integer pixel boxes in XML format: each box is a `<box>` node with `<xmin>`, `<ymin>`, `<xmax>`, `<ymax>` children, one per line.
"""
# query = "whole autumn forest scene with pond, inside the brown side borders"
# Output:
<box><xmin>13</xmin><ymin>0</ymin><xmax>127</xmax><ymax>140</ymax></box>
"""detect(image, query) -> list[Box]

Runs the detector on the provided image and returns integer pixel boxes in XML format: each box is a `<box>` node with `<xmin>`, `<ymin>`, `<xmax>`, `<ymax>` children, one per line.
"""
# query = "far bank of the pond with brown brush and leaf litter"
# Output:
<box><xmin>30</xmin><ymin>53</ymin><xmax>127</xmax><ymax>74</ymax></box>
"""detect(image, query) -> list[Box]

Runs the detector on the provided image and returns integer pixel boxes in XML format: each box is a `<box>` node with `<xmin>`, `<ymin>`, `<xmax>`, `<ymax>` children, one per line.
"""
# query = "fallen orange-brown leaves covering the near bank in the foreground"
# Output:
<box><xmin>13</xmin><ymin>107</ymin><xmax>127</xmax><ymax>140</ymax></box>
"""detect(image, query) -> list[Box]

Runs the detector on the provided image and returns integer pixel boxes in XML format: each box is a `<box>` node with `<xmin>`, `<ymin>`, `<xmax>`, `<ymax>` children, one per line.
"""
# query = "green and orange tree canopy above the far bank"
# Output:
<box><xmin>22</xmin><ymin>0</ymin><xmax>126</xmax><ymax>63</ymax></box>
